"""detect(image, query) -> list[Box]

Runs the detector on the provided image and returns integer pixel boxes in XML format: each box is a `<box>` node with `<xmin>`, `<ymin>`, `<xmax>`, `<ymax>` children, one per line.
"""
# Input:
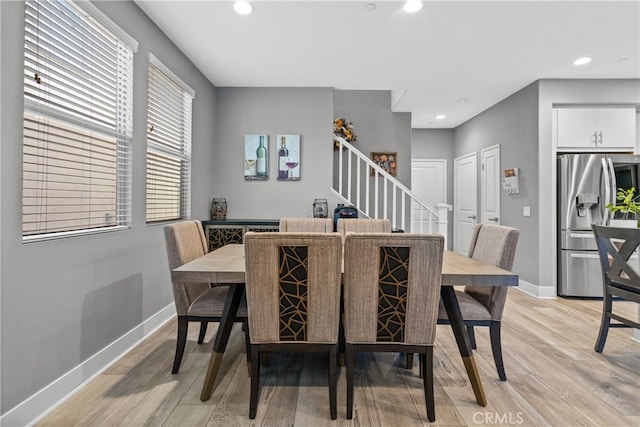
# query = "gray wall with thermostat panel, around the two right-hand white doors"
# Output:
<box><xmin>452</xmin><ymin>83</ymin><xmax>539</xmax><ymax>284</ymax></box>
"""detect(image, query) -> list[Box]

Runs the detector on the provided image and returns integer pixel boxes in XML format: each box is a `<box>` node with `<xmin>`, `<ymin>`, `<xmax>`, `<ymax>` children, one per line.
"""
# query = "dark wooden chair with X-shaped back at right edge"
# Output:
<box><xmin>591</xmin><ymin>224</ymin><xmax>640</xmax><ymax>353</ymax></box>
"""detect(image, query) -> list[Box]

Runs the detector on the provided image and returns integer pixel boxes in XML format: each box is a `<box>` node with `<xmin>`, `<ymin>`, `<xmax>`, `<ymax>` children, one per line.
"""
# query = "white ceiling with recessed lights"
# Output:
<box><xmin>135</xmin><ymin>0</ymin><xmax>640</xmax><ymax>128</ymax></box>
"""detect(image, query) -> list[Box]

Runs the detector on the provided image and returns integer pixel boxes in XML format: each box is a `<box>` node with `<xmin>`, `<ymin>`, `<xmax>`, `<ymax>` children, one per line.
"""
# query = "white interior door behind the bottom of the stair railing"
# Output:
<box><xmin>411</xmin><ymin>159</ymin><xmax>447</xmax><ymax>233</ymax></box>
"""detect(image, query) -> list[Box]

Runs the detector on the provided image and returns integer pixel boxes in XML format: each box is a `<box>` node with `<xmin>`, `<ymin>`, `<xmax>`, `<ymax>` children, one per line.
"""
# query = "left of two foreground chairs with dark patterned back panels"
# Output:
<box><xmin>245</xmin><ymin>232</ymin><xmax>342</xmax><ymax>420</ymax></box>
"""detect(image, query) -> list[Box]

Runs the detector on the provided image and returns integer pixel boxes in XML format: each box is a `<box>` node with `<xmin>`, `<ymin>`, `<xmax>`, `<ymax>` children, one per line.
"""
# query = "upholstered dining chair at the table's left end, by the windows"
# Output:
<box><xmin>164</xmin><ymin>221</ymin><xmax>247</xmax><ymax>374</ymax></box>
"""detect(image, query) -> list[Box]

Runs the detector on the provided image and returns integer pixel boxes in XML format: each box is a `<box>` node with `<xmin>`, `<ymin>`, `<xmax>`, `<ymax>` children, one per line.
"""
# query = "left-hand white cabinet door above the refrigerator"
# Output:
<box><xmin>556</xmin><ymin>108</ymin><xmax>597</xmax><ymax>148</ymax></box>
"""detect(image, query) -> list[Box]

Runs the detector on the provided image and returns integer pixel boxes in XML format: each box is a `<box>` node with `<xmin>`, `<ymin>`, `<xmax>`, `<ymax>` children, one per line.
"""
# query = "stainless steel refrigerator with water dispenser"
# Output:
<box><xmin>558</xmin><ymin>153</ymin><xmax>640</xmax><ymax>297</ymax></box>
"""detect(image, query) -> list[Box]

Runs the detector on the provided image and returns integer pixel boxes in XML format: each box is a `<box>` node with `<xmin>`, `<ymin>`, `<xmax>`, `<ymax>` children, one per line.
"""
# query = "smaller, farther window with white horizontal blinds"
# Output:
<box><xmin>146</xmin><ymin>55</ymin><xmax>194</xmax><ymax>223</ymax></box>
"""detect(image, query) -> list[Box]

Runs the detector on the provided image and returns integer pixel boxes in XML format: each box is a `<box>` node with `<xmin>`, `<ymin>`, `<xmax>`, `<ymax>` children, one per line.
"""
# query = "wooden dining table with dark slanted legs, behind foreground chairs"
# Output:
<box><xmin>171</xmin><ymin>244</ymin><xmax>519</xmax><ymax>406</ymax></box>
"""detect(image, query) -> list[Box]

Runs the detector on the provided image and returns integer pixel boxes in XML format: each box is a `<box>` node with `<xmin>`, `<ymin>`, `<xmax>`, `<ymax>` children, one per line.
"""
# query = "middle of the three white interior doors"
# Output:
<box><xmin>453</xmin><ymin>153</ymin><xmax>478</xmax><ymax>255</ymax></box>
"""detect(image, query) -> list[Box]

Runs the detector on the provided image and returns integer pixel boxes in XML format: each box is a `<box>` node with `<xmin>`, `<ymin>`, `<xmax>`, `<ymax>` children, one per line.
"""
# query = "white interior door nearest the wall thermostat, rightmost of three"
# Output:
<box><xmin>480</xmin><ymin>145</ymin><xmax>501</xmax><ymax>224</ymax></box>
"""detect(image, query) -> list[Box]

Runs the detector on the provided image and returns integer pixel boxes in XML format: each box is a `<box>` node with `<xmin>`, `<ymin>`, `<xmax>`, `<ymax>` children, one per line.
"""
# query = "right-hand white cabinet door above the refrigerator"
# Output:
<box><xmin>597</xmin><ymin>108</ymin><xmax>636</xmax><ymax>150</ymax></box>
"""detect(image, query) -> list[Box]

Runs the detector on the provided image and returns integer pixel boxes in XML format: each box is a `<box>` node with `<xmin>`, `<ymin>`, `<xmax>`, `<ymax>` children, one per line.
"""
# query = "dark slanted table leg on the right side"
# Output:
<box><xmin>440</xmin><ymin>286</ymin><xmax>487</xmax><ymax>406</ymax></box>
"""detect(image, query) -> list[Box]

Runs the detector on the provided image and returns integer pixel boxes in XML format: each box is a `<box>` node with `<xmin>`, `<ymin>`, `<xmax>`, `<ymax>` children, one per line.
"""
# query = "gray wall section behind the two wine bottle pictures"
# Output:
<box><xmin>214</xmin><ymin>88</ymin><xmax>336</xmax><ymax>219</ymax></box>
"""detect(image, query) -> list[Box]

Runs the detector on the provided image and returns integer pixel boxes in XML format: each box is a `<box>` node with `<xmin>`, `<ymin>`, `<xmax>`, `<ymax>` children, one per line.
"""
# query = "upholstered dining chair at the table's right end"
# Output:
<box><xmin>428</xmin><ymin>224</ymin><xmax>520</xmax><ymax>381</ymax></box>
